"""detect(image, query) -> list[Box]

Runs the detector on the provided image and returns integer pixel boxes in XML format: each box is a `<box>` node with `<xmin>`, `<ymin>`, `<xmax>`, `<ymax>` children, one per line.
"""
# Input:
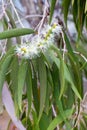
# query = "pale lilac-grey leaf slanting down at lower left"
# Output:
<box><xmin>2</xmin><ymin>82</ymin><xmax>26</xmax><ymax>130</ymax></box>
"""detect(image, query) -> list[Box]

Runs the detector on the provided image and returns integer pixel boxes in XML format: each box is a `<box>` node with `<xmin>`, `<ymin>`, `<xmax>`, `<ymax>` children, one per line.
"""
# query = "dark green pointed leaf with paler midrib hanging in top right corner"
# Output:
<box><xmin>72</xmin><ymin>0</ymin><xmax>86</xmax><ymax>35</ymax></box>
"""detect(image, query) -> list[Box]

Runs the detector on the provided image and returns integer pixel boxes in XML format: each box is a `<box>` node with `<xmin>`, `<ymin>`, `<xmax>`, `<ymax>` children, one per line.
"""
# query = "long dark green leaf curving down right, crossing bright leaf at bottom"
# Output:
<box><xmin>52</xmin><ymin>64</ymin><xmax>71</xmax><ymax>130</ymax></box>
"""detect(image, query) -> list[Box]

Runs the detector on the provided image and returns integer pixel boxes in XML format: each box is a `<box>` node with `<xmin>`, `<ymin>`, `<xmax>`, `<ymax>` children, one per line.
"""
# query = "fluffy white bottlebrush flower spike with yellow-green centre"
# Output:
<box><xmin>16</xmin><ymin>24</ymin><xmax>61</xmax><ymax>59</ymax></box>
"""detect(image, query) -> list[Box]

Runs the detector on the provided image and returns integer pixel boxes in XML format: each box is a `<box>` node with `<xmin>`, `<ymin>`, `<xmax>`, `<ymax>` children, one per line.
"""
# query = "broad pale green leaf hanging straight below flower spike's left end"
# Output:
<box><xmin>18</xmin><ymin>60</ymin><xmax>27</xmax><ymax>110</ymax></box>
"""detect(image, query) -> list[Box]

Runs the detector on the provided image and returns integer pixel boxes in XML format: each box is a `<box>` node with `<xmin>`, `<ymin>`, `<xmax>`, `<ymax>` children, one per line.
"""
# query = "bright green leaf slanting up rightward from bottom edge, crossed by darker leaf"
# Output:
<box><xmin>47</xmin><ymin>109</ymin><xmax>73</xmax><ymax>130</ymax></box>
